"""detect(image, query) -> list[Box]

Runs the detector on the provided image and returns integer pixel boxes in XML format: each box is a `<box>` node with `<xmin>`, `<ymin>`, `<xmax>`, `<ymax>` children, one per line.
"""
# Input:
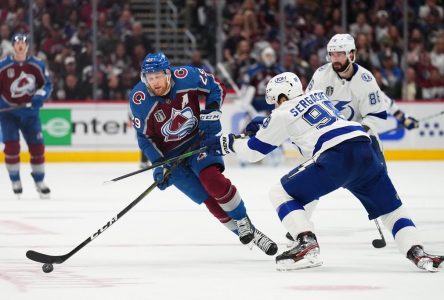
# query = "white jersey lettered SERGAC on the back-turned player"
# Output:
<box><xmin>233</xmin><ymin>91</ymin><xmax>368</xmax><ymax>162</ymax></box>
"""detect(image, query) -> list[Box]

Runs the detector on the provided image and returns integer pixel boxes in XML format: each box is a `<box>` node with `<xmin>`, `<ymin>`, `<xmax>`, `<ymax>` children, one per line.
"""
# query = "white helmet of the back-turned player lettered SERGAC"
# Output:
<box><xmin>265</xmin><ymin>72</ymin><xmax>304</xmax><ymax>105</ymax></box>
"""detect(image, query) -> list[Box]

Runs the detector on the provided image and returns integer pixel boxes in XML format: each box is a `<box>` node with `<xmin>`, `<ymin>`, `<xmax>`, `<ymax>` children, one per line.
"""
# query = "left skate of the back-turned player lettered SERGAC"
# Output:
<box><xmin>276</xmin><ymin>231</ymin><xmax>322</xmax><ymax>271</ymax></box>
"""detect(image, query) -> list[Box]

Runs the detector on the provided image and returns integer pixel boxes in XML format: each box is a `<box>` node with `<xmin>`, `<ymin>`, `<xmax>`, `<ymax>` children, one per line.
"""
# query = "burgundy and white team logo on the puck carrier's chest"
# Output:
<box><xmin>160</xmin><ymin>107</ymin><xmax>197</xmax><ymax>142</ymax></box>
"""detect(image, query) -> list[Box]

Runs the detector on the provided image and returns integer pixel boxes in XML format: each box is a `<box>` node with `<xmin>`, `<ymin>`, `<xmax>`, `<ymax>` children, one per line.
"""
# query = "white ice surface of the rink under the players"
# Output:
<box><xmin>0</xmin><ymin>161</ymin><xmax>444</xmax><ymax>300</ymax></box>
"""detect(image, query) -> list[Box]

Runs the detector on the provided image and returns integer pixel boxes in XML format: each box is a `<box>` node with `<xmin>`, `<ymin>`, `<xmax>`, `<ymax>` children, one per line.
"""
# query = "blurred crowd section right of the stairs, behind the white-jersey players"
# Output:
<box><xmin>219</xmin><ymin>0</ymin><xmax>444</xmax><ymax>100</ymax></box>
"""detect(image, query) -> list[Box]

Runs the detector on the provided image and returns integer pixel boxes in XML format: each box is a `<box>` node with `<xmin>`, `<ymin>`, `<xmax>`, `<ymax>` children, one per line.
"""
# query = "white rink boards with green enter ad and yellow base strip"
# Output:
<box><xmin>0</xmin><ymin>99</ymin><xmax>444</xmax><ymax>162</ymax></box>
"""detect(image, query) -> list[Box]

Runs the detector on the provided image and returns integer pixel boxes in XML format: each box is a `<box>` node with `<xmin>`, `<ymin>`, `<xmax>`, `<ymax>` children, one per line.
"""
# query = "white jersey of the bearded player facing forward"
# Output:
<box><xmin>307</xmin><ymin>63</ymin><xmax>391</xmax><ymax>132</ymax></box>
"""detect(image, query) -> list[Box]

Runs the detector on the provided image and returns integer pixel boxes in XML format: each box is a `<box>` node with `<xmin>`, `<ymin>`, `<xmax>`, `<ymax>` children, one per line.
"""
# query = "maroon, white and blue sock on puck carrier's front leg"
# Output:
<box><xmin>199</xmin><ymin>165</ymin><xmax>247</xmax><ymax>220</ymax></box>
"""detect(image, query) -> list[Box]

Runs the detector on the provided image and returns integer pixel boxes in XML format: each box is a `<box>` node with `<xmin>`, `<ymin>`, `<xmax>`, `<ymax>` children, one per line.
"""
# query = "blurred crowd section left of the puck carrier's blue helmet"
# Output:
<box><xmin>0</xmin><ymin>0</ymin><xmax>152</xmax><ymax>101</ymax></box>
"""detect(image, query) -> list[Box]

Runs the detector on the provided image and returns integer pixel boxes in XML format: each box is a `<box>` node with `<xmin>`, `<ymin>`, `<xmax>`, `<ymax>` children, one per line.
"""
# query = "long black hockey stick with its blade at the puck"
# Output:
<box><xmin>26</xmin><ymin>139</ymin><xmax>204</xmax><ymax>273</ymax></box>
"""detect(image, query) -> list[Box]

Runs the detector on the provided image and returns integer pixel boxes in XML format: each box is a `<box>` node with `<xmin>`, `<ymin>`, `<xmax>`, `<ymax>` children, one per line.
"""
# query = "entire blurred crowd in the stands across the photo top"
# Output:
<box><xmin>0</xmin><ymin>0</ymin><xmax>444</xmax><ymax>101</ymax></box>
